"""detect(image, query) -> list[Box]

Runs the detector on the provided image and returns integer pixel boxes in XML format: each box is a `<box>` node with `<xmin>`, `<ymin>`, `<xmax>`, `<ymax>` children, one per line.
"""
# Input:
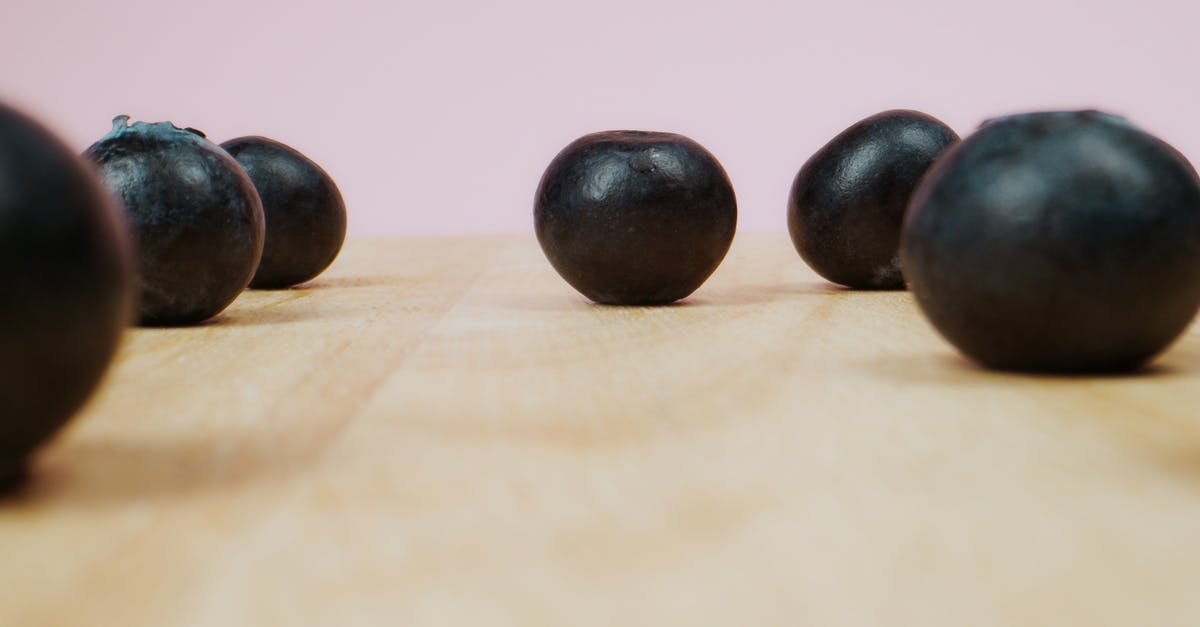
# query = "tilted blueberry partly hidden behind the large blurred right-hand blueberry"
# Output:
<box><xmin>787</xmin><ymin>111</ymin><xmax>959</xmax><ymax>289</ymax></box>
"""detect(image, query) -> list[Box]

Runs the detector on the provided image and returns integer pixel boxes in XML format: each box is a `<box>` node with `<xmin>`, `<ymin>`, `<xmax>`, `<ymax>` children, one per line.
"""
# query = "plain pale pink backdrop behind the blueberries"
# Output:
<box><xmin>0</xmin><ymin>0</ymin><xmax>1200</xmax><ymax>233</ymax></box>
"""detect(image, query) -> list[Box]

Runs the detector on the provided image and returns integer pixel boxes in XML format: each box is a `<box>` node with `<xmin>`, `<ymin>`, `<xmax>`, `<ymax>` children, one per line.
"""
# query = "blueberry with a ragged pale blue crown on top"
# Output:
<box><xmin>84</xmin><ymin>115</ymin><xmax>264</xmax><ymax>326</ymax></box>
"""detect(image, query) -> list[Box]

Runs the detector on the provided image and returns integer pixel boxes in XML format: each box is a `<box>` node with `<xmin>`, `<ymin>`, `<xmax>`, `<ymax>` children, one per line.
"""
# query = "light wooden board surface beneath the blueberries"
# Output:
<box><xmin>0</xmin><ymin>233</ymin><xmax>1200</xmax><ymax>627</ymax></box>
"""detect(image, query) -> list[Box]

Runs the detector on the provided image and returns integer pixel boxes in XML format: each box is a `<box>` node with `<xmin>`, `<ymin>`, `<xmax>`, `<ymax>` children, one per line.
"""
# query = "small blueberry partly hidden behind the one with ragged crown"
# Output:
<box><xmin>221</xmin><ymin>137</ymin><xmax>346</xmax><ymax>289</ymax></box>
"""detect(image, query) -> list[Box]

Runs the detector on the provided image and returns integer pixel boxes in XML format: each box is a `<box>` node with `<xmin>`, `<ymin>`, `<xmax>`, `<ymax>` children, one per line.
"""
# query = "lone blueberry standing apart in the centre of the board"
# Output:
<box><xmin>534</xmin><ymin>131</ymin><xmax>737</xmax><ymax>305</ymax></box>
